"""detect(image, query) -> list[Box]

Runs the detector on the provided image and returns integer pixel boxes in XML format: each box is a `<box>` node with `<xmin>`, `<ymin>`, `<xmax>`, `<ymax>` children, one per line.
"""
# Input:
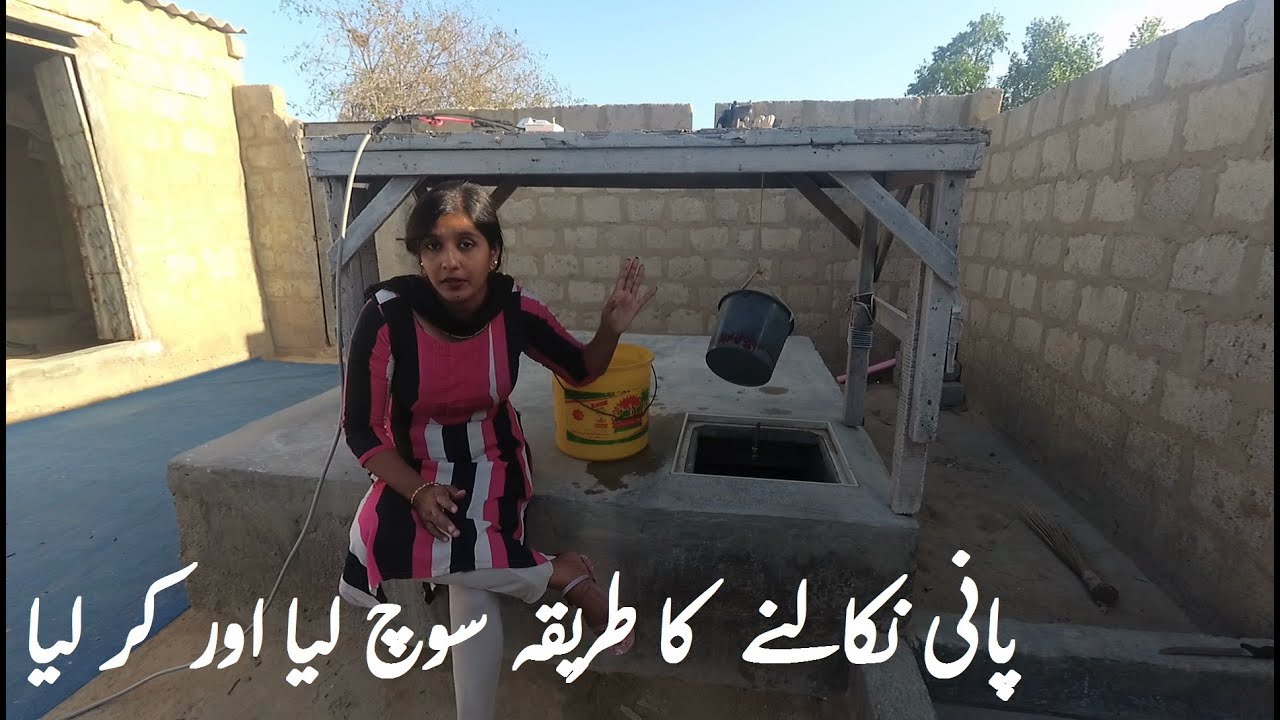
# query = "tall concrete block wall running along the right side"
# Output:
<box><xmin>960</xmin><ymin>0</ymin><xmax>1275</xmax><ymax>635</ymax></box>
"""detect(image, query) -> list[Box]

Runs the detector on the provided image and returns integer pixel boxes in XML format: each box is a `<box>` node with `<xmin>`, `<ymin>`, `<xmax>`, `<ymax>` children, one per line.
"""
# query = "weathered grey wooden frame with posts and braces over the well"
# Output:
<box><xmin>302</xmin><ymin>126</ymin><xmax>989</xmax><ymax>515</ymax></box>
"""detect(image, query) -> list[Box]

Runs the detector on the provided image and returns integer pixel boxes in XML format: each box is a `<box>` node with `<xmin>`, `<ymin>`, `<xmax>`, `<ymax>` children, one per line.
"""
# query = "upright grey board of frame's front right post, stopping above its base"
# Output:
<box><xmin>911</xmin><ymin>173</ymin><xmax>965</xmax><ymax>443</ymax></box>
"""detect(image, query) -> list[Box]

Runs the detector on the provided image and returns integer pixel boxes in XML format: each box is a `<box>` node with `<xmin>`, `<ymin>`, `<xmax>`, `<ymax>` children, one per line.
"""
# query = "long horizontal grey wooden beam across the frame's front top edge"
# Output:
<box><xmin>303</xmin><ymin>141</ymin><xmax>982</xmax><ymax>178</ymax></box>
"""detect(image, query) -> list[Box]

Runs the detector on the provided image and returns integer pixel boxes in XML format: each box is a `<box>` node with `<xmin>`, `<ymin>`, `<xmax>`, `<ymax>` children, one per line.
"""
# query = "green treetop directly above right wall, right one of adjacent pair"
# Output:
<box><xmin>1000</xmin><ymin>17</ymin><xmax>1102</xmax><ymax>108</ymax></box>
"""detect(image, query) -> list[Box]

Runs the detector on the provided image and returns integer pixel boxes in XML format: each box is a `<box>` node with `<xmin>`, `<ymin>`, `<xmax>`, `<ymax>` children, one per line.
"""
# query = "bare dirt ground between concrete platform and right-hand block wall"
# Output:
<box><xmin>865</xmin><ymin>384</ymin><xmax>1197</xmax><ymax>632</ymax></box>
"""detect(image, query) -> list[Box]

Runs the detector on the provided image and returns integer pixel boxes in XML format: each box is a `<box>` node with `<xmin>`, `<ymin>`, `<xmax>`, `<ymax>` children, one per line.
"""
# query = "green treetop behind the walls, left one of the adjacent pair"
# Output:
<box><xmin>906</xmin><ymin>13</ymin><xmax>1009</xmax><ymax>96</ymax></box>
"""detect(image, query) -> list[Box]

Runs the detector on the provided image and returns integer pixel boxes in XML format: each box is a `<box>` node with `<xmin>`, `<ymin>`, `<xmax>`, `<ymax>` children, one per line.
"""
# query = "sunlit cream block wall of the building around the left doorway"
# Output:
<box><xmin>5</xmin><ymin>0</ymin><xmax>273</xmax><ymax>421</ymax></box>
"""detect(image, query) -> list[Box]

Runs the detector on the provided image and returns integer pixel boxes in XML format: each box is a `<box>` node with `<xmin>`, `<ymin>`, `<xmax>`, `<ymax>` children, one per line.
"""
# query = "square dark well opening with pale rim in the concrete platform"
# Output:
<box><xmin>673</xmin><ymin>415</ymin><xmax>858</xmax><ymax>486</ymax></box>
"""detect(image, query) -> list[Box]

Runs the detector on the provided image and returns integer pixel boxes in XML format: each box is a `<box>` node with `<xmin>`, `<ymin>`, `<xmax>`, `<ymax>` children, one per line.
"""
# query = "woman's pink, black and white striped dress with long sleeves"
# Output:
<box><xmin>339</xmin><ymin>286</ymin><xmax>594</xmax><ymax>607</ymax></box>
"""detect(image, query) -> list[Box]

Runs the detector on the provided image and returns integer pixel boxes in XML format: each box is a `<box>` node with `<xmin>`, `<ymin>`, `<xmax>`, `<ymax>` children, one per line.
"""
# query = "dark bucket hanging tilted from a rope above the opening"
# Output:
<box><xmin>707</xmin><ymin>290</ymin><xmax>796</xmax><ymax>387</ymax></box>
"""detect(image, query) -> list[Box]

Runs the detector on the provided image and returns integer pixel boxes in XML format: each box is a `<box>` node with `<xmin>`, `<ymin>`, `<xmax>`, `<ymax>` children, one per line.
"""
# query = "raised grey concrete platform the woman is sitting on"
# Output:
<box><xmin>169</xmin><ymin>336</ymin><xmax>916</xmax><ymax>694</ymax></box>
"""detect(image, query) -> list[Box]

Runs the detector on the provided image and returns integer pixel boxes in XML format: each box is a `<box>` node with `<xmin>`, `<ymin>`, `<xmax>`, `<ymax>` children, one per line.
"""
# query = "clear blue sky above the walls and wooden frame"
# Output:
<box><xmin>197</xmin><ymin>0</ymin><xmax>1229</xmax><ymax>128</ymax></box>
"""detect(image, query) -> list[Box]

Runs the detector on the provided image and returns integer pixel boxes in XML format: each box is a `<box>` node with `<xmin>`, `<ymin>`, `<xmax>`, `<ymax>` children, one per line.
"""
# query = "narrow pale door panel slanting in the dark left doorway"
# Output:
<box><xmin>35</xmin><ymin>55</ymin><xmax>137</xmax><ymax>340</ymax></box>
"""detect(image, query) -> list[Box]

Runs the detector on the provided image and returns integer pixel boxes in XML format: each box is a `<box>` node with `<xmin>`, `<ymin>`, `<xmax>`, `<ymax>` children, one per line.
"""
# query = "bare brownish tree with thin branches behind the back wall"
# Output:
<box><xmin>280</xmin><ymin>0</ymin><xmax>568</xmax><ymax>120</ymax></box>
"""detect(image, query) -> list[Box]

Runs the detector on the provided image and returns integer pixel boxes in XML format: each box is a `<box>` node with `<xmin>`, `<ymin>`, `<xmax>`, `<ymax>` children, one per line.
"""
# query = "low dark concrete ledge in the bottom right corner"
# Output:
<box><xmin>908</xmin><ymin>602</ymin><xmax>1275</xmax><ymax>720</ymax></box>
